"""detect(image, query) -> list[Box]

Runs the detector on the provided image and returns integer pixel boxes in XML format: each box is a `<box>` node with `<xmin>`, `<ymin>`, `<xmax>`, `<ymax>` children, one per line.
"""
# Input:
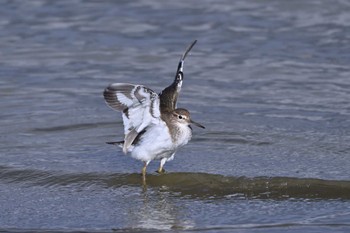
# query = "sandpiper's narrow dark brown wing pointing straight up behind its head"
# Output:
<box><xmin>159</xmin><ymin>40</ymin><xmax>197</xmax><ymax>112</ymax></box>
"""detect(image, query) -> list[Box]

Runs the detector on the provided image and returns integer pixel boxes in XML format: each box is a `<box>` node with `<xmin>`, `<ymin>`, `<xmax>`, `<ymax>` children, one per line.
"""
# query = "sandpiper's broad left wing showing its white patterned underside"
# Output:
<box><xmin>103</xmin><ymin>83</ymin><xmax>160</xmax><ymax>153</ymax></box>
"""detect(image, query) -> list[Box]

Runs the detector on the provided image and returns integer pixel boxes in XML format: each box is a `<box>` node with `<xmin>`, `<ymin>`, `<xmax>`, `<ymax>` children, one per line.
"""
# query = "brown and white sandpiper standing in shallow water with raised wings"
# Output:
<box><xmin>103</xmin><ymin>40</ymin><xmax>204</xmax><ymax>180</ymax></box>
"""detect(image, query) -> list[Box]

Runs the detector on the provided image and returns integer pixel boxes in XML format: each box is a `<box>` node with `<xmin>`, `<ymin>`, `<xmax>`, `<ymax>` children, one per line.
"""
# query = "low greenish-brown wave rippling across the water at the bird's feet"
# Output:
<box><xmin>0</xmin><ymin>166</ymin><xmax>350</xmax><ymax>200</ymax></box>
